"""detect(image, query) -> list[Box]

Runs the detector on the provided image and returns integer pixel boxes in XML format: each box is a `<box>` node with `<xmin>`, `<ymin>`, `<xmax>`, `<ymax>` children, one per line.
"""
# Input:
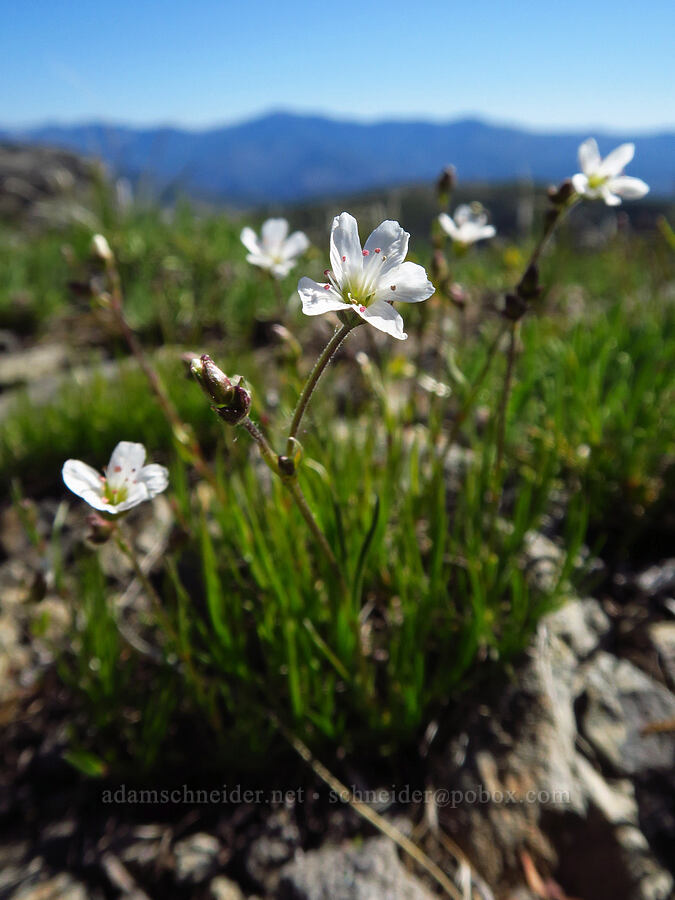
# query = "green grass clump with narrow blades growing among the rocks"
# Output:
<box><xmin>6</xmin><ymin>195</ymin><xmax>675</xmax><ymax>766</ymax></box>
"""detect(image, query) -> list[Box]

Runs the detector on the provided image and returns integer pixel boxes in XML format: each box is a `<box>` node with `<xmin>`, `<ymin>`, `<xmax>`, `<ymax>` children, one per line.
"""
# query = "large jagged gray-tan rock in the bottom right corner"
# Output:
<box><xmin>433</xmin><ymin>600</ymin><xmax>675</xmax><ymax>900</ymax></box>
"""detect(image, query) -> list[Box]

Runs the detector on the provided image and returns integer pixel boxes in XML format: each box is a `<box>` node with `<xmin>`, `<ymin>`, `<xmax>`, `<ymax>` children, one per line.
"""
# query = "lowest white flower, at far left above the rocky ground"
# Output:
<box><xmin>62</xmin><ymin>441</ymin><xmax>169</xmax><ymax>515</ymax></box>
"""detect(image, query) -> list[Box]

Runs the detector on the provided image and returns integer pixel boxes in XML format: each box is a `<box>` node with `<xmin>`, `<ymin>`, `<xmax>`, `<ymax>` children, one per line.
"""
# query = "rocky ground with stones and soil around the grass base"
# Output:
<box><xmin>0</xmin><ymin>472</ymin><xmax>675</xmax><ymax>900</ymax></box>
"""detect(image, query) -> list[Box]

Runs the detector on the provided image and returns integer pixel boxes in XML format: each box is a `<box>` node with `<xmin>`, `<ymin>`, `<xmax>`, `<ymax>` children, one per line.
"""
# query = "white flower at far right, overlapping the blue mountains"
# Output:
<box><xmin>572</xmin><ymin>138</ymin><xmax>649</xmax><ymax>206</ymax></box>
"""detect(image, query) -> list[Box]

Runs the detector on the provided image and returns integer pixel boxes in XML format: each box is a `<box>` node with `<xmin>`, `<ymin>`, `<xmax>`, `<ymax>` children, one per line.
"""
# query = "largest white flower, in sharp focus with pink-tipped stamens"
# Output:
<box><xmin>298</xmin><ymin>213</ymin><xmax>435</xmax><ymax>340</ymax></box>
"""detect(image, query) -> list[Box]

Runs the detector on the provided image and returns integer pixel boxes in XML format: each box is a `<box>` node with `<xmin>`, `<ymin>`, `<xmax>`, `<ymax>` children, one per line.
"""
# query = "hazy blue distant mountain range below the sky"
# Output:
<box><xmin>0</xmin><ymin>113</ymin><xmax>675</xmax><ymax>206</ymax></box>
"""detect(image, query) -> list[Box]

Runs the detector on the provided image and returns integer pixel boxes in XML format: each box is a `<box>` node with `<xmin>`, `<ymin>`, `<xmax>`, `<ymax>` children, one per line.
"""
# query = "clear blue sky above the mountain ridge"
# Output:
<box><xmin>0</xmin><ymin>0</ymin><xmax>675</xmax><ymax>132</ymax></box>
